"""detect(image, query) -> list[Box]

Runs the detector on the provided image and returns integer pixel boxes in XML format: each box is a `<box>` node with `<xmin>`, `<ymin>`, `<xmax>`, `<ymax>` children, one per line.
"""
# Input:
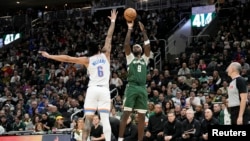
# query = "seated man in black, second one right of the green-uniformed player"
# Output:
<box><xmin>164</xmin><ymin>112</ymin><xmax>182</xmax><ymax>141</ymax></box>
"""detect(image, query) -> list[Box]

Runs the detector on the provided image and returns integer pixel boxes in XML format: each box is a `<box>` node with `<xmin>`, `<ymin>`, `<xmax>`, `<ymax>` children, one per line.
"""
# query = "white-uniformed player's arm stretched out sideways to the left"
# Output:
<box><xmin>38</xmin><ymin>51</ymin><xmax>89</xmax><ymax>67</ymax></box>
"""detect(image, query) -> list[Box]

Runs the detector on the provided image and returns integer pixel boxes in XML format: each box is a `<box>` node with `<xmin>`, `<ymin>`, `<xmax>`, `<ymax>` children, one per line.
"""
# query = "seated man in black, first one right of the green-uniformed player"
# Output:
<box><xmin>143</xmin><ymin>104</ymin><xmax>167</xmax><ymax>141</ymax></box>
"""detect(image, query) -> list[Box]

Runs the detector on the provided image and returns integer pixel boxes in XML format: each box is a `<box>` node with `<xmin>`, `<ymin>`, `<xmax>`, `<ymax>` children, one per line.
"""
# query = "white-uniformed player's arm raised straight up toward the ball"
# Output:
<box><xmin>102</xmin><ymin>9</ymin><xmax>118</xmax><ymax>56</ymax></box>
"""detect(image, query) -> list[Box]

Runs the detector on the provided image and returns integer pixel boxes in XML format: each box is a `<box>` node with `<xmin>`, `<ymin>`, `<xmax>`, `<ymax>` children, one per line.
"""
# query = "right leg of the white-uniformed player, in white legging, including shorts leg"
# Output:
<box><xmin>98</xmin><ymin>88</ymin><xmax>112</xmax><ymax>141</ymax></box>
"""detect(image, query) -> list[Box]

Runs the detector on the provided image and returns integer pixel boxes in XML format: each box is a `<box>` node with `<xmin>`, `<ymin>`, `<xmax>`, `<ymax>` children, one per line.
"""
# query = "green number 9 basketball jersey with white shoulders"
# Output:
<box><xmin>127</xmin><ymin>54</ymin><xmax>148</xmax><ymax>85</ymax></box>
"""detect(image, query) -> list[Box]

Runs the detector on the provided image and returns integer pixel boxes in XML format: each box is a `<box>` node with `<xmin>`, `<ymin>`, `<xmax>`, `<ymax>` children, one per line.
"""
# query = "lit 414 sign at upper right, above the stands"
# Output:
<box><xmin>191</xmin><ymin>5</ymin><xmax>216</xmax><ymax>28</ymax></box>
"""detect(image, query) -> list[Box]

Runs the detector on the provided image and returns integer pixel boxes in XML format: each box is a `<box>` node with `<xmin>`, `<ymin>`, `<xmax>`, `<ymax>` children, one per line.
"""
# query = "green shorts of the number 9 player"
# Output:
<box><xmin>124</xmin><ymin>84</ymin><xmax>148</xmax><ymax>110</ymax></box>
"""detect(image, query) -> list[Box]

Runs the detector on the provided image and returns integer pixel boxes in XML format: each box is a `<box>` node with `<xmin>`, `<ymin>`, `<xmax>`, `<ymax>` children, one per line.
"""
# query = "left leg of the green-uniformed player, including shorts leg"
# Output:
<box><xmin>118</xmin><ymin>86</ymin><xmax>136</xmax><ymax>141</ymax></box>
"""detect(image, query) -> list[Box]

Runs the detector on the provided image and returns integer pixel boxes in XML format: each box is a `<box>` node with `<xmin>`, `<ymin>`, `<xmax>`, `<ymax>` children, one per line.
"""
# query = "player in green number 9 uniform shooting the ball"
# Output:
<box><xmin>118</xmin><ymin>21</ymin><xmax>150</xmax><ymax>141</ymax></box>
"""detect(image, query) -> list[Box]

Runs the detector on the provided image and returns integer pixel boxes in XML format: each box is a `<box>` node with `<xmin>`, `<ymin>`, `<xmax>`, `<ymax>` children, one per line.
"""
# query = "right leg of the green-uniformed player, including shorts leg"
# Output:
<box><xmin>135</xmin><ymin>87</ymin><xmax>148</xmax><ymax>141</ymax></box>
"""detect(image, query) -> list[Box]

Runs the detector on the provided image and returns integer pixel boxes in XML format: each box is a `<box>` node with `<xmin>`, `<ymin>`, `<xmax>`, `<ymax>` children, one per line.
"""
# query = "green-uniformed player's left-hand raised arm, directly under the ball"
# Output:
<box><xmin>124</xmin><ymin>21</ymin><xmax>134</xmax><ymax>55</ymax></box>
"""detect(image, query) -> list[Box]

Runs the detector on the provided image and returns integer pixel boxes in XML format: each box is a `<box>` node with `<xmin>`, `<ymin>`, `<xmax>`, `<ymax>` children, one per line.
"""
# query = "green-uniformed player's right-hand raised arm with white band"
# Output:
<box><xmin>139</xmin><ymin>22</ymin><xmax>150</xmax><ymax>57</ymax></box>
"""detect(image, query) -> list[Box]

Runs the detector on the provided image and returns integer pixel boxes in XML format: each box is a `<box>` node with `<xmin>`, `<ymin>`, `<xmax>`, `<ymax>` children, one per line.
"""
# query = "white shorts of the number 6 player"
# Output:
<box><xmin>84</xmin><ymin>86</ymin><xmax>111</xmax><ymax>115</ymax></box>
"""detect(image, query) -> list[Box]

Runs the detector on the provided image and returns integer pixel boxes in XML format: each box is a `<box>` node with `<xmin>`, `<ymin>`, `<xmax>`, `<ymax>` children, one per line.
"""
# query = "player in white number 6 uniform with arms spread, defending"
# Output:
<box><xmin>39</xmin><ymin>10</ymin><xmax>118</xmax><ymax>141</ymax></box>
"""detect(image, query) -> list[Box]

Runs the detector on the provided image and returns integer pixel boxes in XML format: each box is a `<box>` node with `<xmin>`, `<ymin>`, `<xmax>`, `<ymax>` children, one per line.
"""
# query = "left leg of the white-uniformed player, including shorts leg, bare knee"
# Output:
<box><xmin>83</xmin><ymin>87</ymin><xmax>98</xmax><ymax>141</ymax></box>
